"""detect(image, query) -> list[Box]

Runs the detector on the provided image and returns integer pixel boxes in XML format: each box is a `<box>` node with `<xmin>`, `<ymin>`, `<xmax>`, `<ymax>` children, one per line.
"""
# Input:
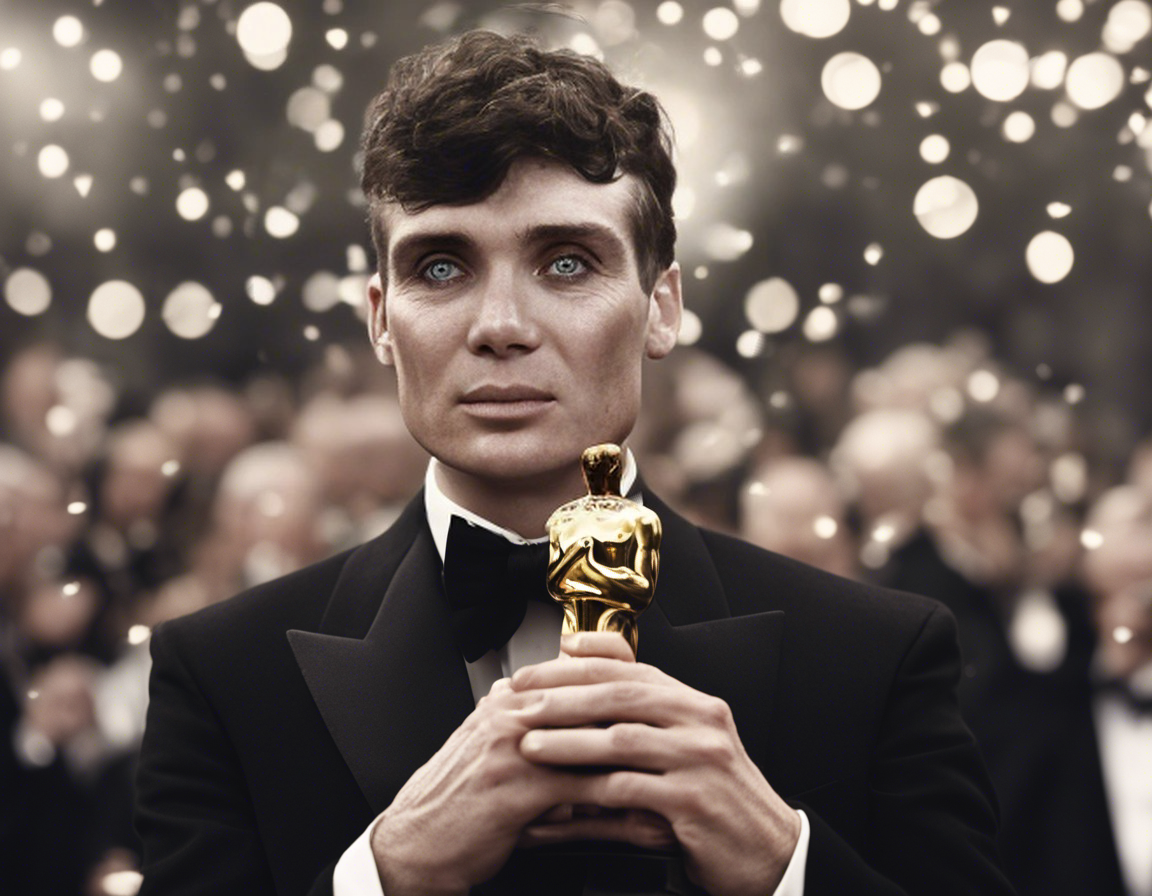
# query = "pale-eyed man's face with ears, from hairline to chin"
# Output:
<box><xmin>369</xmin><ymin>160</ymin><xmax>680</xmax><ymax>488</ymax></box>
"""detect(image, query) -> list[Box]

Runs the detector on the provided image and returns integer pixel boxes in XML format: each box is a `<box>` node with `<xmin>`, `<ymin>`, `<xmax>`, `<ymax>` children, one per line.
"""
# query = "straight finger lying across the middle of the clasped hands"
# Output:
<box><xmin>520</xmin><ymin>722</ymin><xmax>718</xmax><ymax>772</ymax></box>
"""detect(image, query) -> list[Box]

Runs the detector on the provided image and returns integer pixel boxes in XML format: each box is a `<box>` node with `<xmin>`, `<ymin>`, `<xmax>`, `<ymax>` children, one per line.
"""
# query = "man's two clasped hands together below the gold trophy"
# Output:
<box><xmin>372</xmin><ymin>632</ymin><xmax>801</xmax><ymax>896</ymax></box>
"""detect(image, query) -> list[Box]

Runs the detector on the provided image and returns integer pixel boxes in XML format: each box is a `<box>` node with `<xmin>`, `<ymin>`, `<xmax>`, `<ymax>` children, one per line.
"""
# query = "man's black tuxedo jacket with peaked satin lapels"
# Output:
<box><xmin>136</xmin><ymin>495</ymin><xmax>1011</xmax><ymax>896</ymax></box>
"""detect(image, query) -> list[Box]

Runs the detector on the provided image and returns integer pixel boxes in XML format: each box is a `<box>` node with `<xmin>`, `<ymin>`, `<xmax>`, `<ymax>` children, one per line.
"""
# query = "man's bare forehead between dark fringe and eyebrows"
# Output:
<box><xmin>380</xmin><ymin>159</ymin><xmax>637</xmax><ymax>257</ymax></box>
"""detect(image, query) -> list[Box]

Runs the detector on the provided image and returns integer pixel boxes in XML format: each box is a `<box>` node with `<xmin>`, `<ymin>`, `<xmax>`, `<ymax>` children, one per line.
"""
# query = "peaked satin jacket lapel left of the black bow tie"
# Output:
<box><xmin>288</xmin><ymin>502</ymin><xmax>473</xmax><ymax>812</ymax></box>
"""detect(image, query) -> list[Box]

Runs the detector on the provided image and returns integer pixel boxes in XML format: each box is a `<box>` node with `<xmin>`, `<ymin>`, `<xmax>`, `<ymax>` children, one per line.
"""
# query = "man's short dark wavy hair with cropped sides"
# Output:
<box><xmin>361</xmin><ymin>31</ymin><xmax>676</xmax><ymax>291</ymax></box>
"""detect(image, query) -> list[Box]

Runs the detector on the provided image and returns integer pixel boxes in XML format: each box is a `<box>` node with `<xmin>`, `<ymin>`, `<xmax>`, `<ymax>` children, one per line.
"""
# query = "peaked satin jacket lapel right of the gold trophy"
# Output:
<box><xmin>637</xmin><ymin>493</ymin><xmax>785</xmax><ymax>770</ymax></box>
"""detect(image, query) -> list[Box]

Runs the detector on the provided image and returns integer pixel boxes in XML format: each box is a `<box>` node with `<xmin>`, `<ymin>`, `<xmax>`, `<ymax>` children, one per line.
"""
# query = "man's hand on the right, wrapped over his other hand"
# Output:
<box><xmin>511</xmin><ymin>632</ymin><xmax>801</xmax><ymax>896</ymax></box>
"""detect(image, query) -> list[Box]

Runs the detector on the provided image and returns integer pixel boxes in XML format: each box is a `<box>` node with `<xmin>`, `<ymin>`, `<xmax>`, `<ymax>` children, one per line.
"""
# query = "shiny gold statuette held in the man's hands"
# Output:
<box><xmin>548</xmin><ymin>443</ymin><xmax>661</xmax><ymax>653</ymax></box>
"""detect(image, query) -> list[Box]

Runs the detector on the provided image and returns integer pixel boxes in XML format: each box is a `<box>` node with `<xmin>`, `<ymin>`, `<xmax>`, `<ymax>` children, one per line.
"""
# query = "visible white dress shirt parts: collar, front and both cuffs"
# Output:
<box><xmin>332</xmin><ymin>460</ymin><xmax>810</xmax><ymax>896</ymax></box>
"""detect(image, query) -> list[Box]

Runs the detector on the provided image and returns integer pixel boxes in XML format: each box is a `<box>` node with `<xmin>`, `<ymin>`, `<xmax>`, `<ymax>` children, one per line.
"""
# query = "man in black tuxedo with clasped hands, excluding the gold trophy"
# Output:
<box><xmin>138</xmin><ymin>32</ymin><xmax>1010</xmax><ymax>896</ymax></box>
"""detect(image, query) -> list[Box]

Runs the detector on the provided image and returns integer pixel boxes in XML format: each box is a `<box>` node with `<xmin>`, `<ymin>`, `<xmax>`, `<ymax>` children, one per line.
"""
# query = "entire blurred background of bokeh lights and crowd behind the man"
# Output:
<box><xmin>0</xmin><ymin>0</ymin><xmax>1152</xmax><ymax>896</ymax></box>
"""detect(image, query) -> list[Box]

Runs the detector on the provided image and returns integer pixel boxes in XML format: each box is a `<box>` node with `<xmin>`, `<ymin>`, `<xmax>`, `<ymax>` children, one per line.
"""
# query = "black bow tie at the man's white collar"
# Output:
<box><xmin>444</xmin><ymin>516</ymin><xmax>552</xmax><ymax>662</ymax></box>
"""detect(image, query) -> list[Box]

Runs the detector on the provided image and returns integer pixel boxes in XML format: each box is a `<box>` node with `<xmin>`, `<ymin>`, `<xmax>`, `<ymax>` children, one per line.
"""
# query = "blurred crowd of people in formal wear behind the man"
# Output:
<box><xmin>0</xmin><ymin>335</ymin><xmax>1152</xmax><ymax>896</ymax></box>
